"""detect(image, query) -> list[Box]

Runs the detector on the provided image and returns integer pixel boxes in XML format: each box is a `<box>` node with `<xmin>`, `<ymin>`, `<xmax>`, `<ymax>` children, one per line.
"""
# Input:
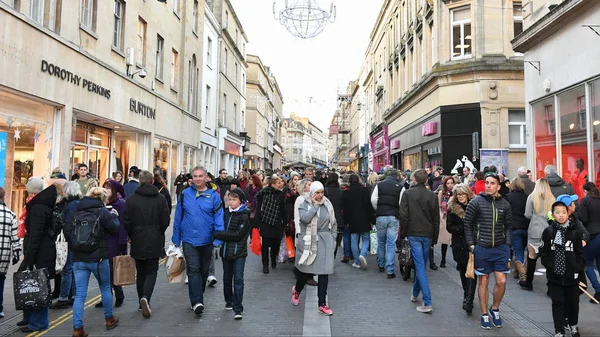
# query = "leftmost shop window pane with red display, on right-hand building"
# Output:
<box><xmin>531</xmin><ymin>97</ymin><xmax>556</xmax><ymax>178</ymax></box>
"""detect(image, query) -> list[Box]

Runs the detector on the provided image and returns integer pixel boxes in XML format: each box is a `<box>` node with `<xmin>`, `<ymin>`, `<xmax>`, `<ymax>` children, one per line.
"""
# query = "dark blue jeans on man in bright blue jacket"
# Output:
<box><xmin>183</xmin><ymin>242</ymin><xmax>213</xmax><ymax>307</ymax></box>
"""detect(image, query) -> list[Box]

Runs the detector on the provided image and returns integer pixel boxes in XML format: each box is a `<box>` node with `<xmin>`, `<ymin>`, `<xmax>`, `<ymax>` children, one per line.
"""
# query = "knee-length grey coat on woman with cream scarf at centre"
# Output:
<box><xmin>296</xmin><ymin>200</ymin><xmax>337</xmax><ymax>275</ymax></box>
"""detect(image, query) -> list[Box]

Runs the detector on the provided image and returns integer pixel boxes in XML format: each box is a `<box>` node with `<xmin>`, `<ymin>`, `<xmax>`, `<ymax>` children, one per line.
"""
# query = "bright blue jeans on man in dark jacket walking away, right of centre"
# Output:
<box><xmin>408</xmin><ymin>236</ymin><xmax>431</xmax><ymax>305</ymax></box>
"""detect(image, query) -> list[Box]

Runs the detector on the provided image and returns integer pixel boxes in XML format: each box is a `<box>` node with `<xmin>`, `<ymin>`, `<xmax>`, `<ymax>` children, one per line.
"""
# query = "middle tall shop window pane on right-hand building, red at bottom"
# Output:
<box><xmin>558</xmin><ymin>86</ymin><xmax>588</xmax><ymax>187</ymax></box>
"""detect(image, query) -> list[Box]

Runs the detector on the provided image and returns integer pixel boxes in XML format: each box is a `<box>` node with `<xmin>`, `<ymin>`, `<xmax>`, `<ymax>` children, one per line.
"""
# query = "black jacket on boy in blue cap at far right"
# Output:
<box><xmin>540</xmin><ymin>221</ymin><xmax>585</xmax><ymax>287</ymax></box>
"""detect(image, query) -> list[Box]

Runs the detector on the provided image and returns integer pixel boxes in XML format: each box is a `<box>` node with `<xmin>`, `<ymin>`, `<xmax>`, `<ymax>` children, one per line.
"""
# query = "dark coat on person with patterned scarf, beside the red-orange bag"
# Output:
<box><xmin>255</xmin><ymin>186</ymin><xmax>287</xmax><ymax>240</ymax></box>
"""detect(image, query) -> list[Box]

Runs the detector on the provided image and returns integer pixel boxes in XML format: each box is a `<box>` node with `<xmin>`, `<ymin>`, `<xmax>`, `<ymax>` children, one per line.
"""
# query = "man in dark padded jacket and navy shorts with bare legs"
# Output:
<box><xmin>464</xmin><ymin>172</ymin><xmax>512</xmax><ymax>329</ymax></box>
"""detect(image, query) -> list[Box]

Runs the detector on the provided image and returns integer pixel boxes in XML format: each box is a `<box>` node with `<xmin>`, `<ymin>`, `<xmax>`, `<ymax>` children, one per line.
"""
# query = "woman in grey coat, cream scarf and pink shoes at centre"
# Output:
<box><xmin>292</xmin><ymin>181</ymin><xmax>337</xmax><ymax>316</ymax></box>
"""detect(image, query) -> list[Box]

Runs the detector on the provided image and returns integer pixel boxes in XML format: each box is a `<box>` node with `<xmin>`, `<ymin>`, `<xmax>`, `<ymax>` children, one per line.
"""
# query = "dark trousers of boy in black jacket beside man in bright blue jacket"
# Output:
<box><xmin>222</xmin><ymin>257</ymin><xmax>246</xmax><ymax>314</ymax></box>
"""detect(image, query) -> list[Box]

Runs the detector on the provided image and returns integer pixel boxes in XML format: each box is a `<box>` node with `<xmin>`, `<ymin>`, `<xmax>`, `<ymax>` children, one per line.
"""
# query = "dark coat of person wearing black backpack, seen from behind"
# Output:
<box><xmin>64</xmin><ymin>197</ymin><xmax>120</xmax><ymax>262</ymax></box>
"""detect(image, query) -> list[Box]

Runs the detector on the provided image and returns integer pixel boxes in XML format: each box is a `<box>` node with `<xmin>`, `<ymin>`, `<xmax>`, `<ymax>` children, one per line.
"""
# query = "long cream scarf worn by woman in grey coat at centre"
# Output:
<box><xmin>298</xmin><ymin>181</ymin><xmax>336</xmax><ymax>266</ymax></box>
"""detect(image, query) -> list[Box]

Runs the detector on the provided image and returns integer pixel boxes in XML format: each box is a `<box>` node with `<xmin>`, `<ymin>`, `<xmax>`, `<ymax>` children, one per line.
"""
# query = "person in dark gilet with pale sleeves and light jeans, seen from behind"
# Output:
<box><xmin>371</xmin><ymin>169</ymin><xmax>404</xmax><ymax>279</ymax></box>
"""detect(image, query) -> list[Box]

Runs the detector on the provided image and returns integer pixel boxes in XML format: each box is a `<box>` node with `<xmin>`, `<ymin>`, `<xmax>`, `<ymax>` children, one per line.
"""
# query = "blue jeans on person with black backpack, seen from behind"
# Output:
<box><xmin>73</xmin><ymin>259</ymin><xmax>112</xmax><ymax>329</ymax></box>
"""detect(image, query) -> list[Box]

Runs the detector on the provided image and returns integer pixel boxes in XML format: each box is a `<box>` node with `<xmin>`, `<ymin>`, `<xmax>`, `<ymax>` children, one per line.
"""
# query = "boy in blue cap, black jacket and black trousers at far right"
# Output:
<box><xmin>540</xmin><ymin>195</ymin><xmax>585</xmax><ymax>337</ymax></box>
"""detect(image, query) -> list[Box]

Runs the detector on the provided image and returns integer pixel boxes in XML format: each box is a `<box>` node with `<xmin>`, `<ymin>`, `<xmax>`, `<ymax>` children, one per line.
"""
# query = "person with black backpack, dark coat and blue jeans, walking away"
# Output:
<box><xmin>64</xmin><ymin>187</ymin><xmax>120</xmax><ymax>337</ymax></box>
